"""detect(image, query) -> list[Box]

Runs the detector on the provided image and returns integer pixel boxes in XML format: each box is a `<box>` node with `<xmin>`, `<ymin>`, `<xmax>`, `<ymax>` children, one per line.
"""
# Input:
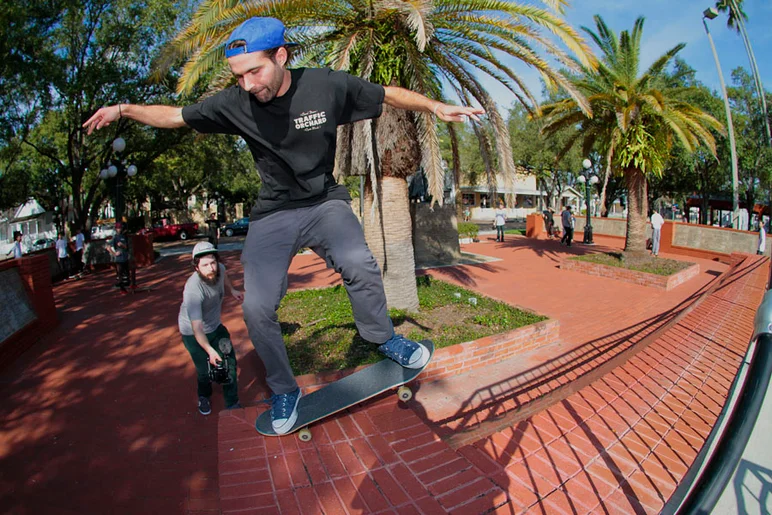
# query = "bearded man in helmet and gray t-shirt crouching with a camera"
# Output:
<box><xmin>177</xmin><ymin>241</ymin><xmax>244</xmax><ymax>415</ymax></box>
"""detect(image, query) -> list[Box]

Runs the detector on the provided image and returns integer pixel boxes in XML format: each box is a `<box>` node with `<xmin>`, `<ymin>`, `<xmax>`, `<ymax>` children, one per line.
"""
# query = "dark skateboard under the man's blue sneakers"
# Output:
<box><xmin>255</xmin><ymin>340</ymin><xmax>434</xmax><ymax>442</ymax></box>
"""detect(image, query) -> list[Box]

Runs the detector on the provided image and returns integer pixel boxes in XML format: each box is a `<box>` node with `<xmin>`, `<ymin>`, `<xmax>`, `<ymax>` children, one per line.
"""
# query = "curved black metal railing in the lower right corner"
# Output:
<box><xmin>661</xmin><ymin>260</ymin><xmax>772</xmax><ymax>515</ymax></box>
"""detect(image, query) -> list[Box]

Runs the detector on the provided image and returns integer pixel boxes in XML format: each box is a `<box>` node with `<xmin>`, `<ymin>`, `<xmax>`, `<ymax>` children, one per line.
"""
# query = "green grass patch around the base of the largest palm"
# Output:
<box><xmin>279</xmin><ymin>276</ymin><xmax>546</xmax><ymax>375</ymax></box>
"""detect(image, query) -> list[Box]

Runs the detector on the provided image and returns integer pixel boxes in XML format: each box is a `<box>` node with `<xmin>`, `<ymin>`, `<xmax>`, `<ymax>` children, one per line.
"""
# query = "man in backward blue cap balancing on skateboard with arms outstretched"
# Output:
<box><xmin>84</xmin><ymin>18</ymin><xmax>484</xmax><ymax>434</ymax></box>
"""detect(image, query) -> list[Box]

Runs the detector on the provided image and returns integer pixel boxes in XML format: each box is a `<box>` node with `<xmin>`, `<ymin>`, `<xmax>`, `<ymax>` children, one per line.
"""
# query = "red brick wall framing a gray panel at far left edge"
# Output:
<box><xmin>0</xmin><ymin>254</ymin><xmax>59</xmax><ymax>369</ymax></box>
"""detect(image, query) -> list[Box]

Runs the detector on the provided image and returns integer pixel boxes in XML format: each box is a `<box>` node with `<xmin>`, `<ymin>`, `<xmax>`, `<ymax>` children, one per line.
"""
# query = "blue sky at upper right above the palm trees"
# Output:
<box><xmin>484</xmin><ymin>0</ymin><xmax>772</xmax><ymax>107</ymax></box>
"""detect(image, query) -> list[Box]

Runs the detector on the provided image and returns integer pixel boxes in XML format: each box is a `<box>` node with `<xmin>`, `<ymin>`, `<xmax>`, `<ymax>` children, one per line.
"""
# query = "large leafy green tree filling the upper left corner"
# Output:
<box><xmin>0</xmin><ymin>0</ymin><xmax>191</xmax><ymax>232</ymax></box>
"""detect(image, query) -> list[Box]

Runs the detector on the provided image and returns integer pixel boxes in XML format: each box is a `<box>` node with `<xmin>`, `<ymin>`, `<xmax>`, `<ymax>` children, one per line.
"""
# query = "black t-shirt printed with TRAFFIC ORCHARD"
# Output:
<box><xmin>182</xmin><ymin>68</ymin><xmax>385</xmax><ymax>220</ymax></box>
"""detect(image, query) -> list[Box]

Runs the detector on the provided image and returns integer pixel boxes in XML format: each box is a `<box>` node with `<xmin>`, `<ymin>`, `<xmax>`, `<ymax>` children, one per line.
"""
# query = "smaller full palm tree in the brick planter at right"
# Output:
<box><xmin>542</xmin><ymin>16</ymin><xmax>722</xmax><ymax>252</ymax></box>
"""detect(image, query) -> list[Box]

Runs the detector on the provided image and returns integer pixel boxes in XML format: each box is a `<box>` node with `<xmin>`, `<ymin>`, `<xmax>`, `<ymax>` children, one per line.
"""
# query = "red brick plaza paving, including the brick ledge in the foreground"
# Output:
<box><xmin>0</xmin><ymin>238</ymin><xmax>766</xmax><ymax>514</ymax></box>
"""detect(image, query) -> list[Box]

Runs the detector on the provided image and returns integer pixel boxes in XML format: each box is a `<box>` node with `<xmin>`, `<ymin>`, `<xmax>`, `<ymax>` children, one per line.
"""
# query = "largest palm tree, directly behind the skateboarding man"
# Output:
<box><xmin>162</xmin><ymin>0</ymin><xmax>594</xmax><ymax>310</ymax></box>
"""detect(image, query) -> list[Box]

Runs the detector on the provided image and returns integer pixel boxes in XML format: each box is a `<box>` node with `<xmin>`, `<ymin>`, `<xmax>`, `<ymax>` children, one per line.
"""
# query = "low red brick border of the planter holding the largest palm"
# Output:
<box><xmin>297</xmin><ymin>320</ymin><xmax>560</xmax><ymax>392</ymax></box>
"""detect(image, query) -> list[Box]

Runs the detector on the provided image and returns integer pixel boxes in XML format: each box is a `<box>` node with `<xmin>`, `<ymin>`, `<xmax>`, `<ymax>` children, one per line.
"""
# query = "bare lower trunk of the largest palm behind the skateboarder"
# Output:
<box><xmin>365</xmin><ymin>177</ymin><xmax>418</xmax><ymax>312</ymax></box>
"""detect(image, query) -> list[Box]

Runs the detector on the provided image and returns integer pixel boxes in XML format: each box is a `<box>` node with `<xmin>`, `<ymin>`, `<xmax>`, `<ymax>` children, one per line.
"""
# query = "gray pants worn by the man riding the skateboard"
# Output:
<box><xmin>241</xmin><ymin>200</ymin><xmax>394</xmax><ymax>394</ymax></box>
